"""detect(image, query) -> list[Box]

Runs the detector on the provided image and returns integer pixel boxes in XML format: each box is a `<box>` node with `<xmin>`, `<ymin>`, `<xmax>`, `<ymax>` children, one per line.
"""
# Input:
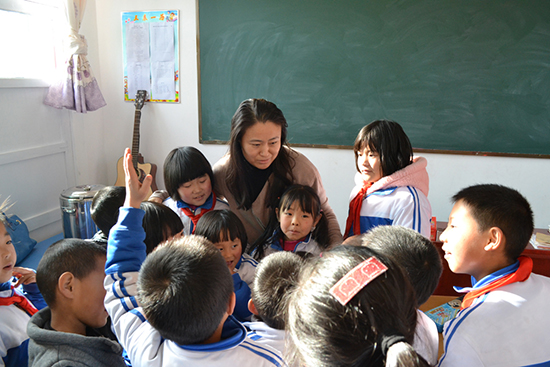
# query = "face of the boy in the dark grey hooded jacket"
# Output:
<box><xmin>73</xmin><ymin>256</ymin><xmax>109</xmax><ymax>328</ymax></box>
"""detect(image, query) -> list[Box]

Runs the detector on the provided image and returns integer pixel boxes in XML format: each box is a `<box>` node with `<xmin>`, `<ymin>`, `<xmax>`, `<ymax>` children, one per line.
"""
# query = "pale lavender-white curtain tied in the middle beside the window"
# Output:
<box><xmin>44</xmin><ymin>0</ymin><xmax>106</xmax><ymax>113</ymax></box>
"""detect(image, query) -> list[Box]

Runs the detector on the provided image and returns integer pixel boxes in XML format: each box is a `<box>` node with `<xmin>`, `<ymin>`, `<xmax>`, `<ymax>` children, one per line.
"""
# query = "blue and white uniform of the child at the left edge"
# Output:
<box><xmin>0</xmin><ymin>281</ymin><xmax>46</xmax><ymax>367</ymax></box>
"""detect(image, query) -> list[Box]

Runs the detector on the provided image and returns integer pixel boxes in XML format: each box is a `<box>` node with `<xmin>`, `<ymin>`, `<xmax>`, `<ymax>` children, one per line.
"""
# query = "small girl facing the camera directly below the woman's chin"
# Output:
<box><xmin>250</xmin><ymin>185</ymin><xmax>329</xmax><ymax>259</ymax></box>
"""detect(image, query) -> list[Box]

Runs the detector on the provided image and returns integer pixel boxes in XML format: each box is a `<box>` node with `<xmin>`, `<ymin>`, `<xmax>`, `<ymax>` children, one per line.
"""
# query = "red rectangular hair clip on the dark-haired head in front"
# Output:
<box><xmin>330</xmin><ymin>256</ymin><xmax>388</xmax><ymax>306</ymax></box>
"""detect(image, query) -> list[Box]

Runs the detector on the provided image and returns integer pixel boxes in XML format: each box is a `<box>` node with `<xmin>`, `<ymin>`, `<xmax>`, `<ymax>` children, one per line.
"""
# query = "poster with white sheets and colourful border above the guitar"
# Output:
<box><xmin>122</xmin><ymin>10</ymin><xmax>179</xmax><ymax>102</ymax></box>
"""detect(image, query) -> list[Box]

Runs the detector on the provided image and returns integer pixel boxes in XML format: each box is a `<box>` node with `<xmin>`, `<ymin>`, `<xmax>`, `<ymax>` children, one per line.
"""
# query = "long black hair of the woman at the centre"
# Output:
<box><xmin>227</xmin><ymin>99</ymin><xmax>294</xmax><ymax>210</ymax></box>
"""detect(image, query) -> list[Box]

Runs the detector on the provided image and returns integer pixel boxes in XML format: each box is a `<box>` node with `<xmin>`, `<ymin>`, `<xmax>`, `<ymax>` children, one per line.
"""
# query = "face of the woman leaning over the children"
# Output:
<box><xmin>241</xmin><ymin>121</ymin><xmax>281</xmax><ymax>169</ymax></box>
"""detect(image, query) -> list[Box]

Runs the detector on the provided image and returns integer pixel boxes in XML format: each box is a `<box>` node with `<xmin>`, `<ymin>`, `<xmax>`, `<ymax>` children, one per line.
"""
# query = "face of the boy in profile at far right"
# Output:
<box><xmin>440</xmin><ymin>200</ymin><xmax>490</xmax><ymax>280</ymax></box>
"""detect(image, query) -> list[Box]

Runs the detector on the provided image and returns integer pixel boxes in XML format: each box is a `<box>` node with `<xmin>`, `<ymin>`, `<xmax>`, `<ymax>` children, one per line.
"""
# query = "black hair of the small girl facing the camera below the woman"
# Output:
<box><xmin>251</xmin><ymin>184</ymin><xmax>330</xmax><ymax>260</ymax></box>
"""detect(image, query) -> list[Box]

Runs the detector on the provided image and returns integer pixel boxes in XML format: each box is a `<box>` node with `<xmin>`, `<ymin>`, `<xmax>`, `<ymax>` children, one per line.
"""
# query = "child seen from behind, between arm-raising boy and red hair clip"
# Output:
<box><xmin>244</xmin><ymin>251</ymin><xmax>304</xmax><ymax>355</ymax></box>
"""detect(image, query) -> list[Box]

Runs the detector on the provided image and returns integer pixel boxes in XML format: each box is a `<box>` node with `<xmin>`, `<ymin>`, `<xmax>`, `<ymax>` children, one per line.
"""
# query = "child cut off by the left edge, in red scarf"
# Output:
<box><xmin>0</xmin><ymin>200</ymin><xmax>46</xmax><ymax>367</ymax></box>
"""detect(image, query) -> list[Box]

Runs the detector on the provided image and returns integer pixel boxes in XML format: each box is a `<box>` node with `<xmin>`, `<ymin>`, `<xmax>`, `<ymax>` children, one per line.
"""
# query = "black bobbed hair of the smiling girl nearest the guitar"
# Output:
<box><xmin>164</xmin><ymin>147</ymin><xmax>214</xmax><ymax>201</ymax></box>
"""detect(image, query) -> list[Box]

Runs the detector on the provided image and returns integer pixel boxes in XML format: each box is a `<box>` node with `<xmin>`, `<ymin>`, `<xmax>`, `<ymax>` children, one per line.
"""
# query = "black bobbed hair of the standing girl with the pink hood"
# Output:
<box><xmin>353</xmin><ymin>120</ymin><xmax>413</xmax><ymax>176</ymax></box>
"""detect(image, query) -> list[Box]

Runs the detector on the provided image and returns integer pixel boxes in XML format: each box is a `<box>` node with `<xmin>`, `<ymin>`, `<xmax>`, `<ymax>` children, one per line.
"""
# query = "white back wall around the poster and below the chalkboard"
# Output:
<box><xmin>90</xmin><ymin>0</ymin><xmax>550</xmax><ymax>233</ymax></box>
